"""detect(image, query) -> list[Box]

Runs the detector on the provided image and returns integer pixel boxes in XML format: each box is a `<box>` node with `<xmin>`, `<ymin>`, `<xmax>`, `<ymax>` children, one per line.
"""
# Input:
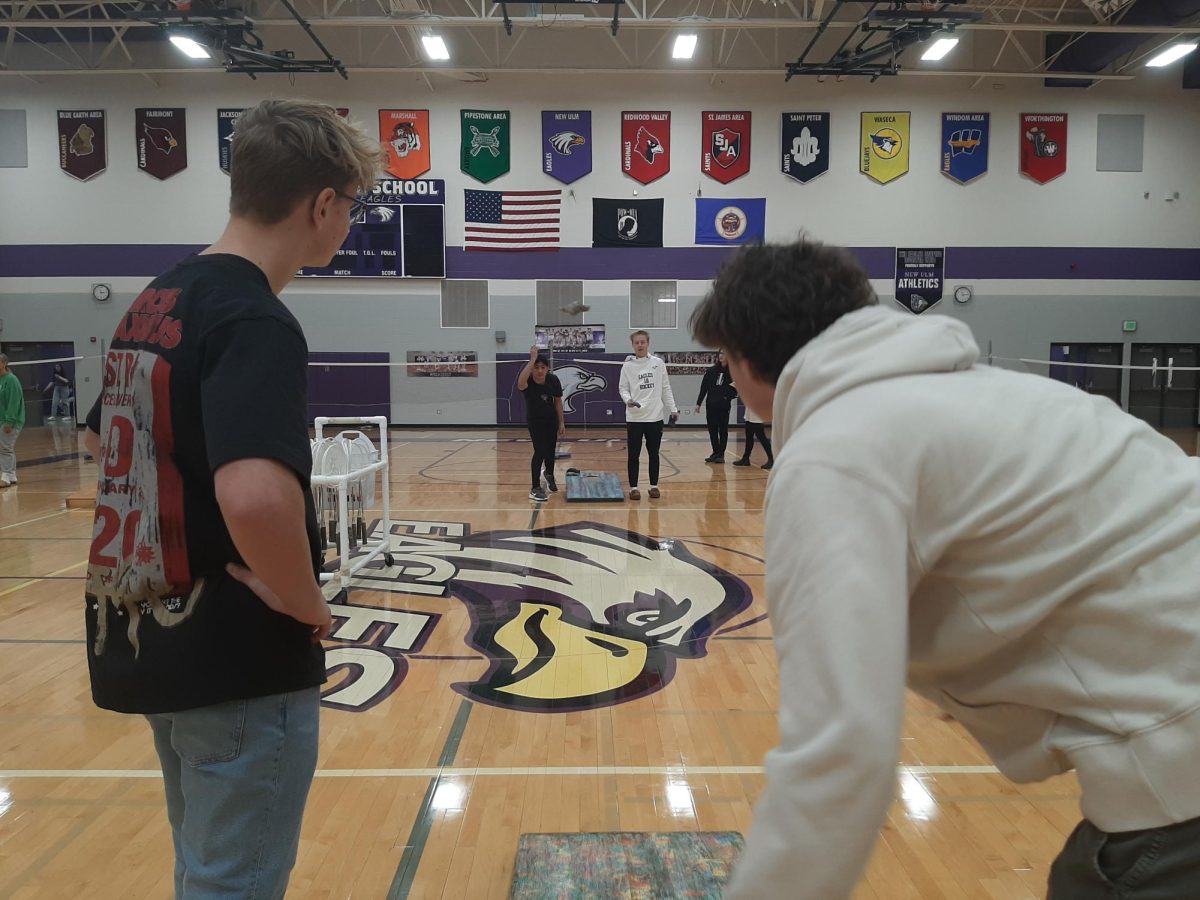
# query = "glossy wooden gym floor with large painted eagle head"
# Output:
<box><xmin>0</xmin><ymin>425</ymin><xmax>1196</xmax><ymax>900</ymax></box>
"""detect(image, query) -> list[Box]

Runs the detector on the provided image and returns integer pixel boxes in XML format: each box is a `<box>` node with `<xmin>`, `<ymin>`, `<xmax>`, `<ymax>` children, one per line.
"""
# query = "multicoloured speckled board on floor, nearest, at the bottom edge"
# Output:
<box><xmin>510</xmin><ymin>832</ymin><xmax>742</xmax><ymax>900</ymax></box>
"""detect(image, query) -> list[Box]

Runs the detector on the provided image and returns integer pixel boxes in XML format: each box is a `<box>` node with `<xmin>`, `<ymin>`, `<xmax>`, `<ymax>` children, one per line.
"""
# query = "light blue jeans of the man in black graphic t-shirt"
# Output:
<box><xmin>146</xmin><ymin>688</ymin><xmax>320</xmax><ymax>900</ymax></box>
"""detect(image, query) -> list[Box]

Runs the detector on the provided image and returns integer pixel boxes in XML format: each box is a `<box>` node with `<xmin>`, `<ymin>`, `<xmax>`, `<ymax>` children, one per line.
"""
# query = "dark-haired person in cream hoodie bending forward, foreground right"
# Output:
<box><xmin>691</xmin><ymin>239</ymin><xmax>1200</xmax><ymax>900</ymax></box>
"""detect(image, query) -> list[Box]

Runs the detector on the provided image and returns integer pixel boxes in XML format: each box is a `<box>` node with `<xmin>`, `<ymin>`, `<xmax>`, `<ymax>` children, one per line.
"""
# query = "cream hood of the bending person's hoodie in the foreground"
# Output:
<box><xmin>773</xmin><ymin>306</ymin><xmax>979</xmax><ymax>446</ymax></box>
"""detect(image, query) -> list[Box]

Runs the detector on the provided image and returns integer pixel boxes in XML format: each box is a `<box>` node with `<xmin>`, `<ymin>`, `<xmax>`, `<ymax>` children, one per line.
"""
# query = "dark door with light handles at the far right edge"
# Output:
<box><xmin>1129</xmin><ymin>343</ymin><xmax>1200</xmax><ymax>428</ymax></box>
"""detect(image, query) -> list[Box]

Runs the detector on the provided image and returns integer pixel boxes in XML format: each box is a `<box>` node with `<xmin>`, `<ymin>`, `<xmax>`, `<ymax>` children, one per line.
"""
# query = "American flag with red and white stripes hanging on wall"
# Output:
<box><xmin>464</xmin><ymin>191</ymin><xmax>563</xmax><ymax>250</ymax></box>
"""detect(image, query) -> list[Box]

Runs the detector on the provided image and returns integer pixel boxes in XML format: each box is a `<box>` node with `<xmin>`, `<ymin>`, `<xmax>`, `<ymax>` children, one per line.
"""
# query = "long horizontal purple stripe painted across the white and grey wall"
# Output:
<box><xmin>0</xmin><ymin>244</ymin><xmax>1200</xmax><ymax>281</ymax></box>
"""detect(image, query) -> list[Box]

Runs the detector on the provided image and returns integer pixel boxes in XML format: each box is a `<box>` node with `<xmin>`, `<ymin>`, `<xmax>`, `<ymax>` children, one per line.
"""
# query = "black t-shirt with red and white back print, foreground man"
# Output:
<box><xmin>86</xmin><ymin>254</ymin><xmax>325</xmax><ymax>713</ymax></box>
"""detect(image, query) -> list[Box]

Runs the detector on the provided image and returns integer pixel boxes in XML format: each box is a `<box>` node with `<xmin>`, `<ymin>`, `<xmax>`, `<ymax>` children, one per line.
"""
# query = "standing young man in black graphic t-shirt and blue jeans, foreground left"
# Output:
<box><xmin>85</xmin><ymin>101</ymin><xmax>380</xmax><ymax>900</ymax></box>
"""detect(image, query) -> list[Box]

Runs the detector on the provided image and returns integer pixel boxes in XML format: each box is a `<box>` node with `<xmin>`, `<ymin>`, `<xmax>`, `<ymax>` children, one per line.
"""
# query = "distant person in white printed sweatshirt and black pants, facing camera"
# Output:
<box><xmin>618</xmin><ymin>331</ymin><xmax>679</xmax><ymax>500</ymax></box>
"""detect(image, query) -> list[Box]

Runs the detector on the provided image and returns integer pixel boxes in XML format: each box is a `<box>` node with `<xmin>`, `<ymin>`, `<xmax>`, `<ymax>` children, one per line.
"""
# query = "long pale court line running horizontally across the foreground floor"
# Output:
<box><xmin>0</xmin><ymin>766</ymin><xmax>1000</xmax><ymax>780</ymax></box>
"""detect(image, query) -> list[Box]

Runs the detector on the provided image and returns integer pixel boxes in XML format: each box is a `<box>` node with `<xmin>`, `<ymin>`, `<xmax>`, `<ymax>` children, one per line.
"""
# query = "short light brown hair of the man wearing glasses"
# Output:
<box><xmin>229</xmin><ymin>100</ymin><xmax>386</xmax><ymax>224</ymax></box>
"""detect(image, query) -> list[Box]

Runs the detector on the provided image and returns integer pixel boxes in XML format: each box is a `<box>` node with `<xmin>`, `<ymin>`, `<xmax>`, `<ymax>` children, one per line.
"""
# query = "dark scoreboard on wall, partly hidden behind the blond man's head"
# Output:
<box><xmin>300</xmin><ymin>179</ymin><xmax>446</xmax><ymax>278</ymax></box>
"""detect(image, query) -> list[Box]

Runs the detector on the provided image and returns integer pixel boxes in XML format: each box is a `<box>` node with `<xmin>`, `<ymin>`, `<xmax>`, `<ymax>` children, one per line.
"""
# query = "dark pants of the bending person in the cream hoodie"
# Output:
<box><xmin>1046</xmin><ymin>818</ymin><xmax>1200</xmax><ymax>900</ymax></box>
